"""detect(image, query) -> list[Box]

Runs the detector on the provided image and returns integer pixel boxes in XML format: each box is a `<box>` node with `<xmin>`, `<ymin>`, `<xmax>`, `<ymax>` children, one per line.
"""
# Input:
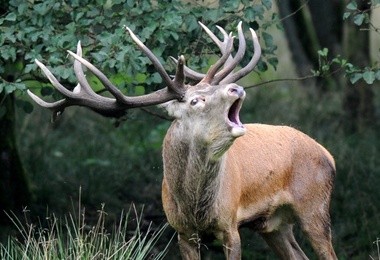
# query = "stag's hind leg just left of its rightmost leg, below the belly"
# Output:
<box><xmin>260</xmin><ymin>224</ymin><xmax>308</xmax><ymax>259</ymax></box>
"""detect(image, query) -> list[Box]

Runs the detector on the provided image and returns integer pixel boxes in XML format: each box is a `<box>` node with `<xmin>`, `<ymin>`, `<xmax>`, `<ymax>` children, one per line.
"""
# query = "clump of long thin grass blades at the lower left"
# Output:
<box><xmin>0</xmin><ymin>192</ymin><xmax>170</xmax><ymax>260</ymax></box>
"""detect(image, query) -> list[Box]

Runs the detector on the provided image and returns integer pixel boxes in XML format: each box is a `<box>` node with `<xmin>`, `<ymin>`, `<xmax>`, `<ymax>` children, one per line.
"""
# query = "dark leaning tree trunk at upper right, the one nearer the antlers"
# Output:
<box><xmin>277</xmin><ymin>0</ymin><xmax>342</xmax><ymax>92</ymax></box>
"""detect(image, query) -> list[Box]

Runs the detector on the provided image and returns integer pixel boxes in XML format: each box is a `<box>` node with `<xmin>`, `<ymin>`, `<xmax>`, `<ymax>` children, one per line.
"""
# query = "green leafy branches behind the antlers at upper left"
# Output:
<box><xmin>0</xmin><ymin>0</ymin><xmax>278</xmax><ymax>110</ymax></box>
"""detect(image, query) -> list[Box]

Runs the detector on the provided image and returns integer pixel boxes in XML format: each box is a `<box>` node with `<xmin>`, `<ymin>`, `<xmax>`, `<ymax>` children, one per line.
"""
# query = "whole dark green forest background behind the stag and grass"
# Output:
<box><xmin>0</xmin><ymin>0</ymin><xmax>380</xmax><ymax>259</ymax></box>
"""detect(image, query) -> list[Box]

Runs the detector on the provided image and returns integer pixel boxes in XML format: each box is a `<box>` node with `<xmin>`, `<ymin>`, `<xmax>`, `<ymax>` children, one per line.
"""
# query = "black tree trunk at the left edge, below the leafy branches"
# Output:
<box><xmin>0</xmin><ymin>93</ymin><xmax>31</xmax><ymax>223</ymax></box>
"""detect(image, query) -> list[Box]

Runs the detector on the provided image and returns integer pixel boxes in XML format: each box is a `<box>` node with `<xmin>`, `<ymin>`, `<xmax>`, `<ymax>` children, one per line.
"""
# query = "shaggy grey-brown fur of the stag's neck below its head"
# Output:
<box><xmin>163</xmin><ymin>122</ymin><xmax>229</xmax><ymax>229</ymax></box>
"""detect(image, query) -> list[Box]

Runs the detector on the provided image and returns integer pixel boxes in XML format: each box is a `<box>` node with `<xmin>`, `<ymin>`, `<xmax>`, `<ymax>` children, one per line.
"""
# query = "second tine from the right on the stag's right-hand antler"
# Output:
<box><xmin>212</xmin><ymin>21</ymin><xmax>246</xmax><ymax>84</ymax></box>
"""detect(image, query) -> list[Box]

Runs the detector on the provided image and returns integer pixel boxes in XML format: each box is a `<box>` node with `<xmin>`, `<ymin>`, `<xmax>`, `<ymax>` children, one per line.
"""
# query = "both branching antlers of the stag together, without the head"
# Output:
<box><xmin>28</xmin><ymin>22</ymin><xmax>261</xmax><ymax>120</ymax></box>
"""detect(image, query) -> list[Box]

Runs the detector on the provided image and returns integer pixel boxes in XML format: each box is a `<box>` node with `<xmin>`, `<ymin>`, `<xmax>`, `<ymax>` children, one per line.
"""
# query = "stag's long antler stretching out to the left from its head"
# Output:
<box><xmin>28</xmin><ymin>27</ymin><xmax>186</xmax><ymax>120</ymax></box>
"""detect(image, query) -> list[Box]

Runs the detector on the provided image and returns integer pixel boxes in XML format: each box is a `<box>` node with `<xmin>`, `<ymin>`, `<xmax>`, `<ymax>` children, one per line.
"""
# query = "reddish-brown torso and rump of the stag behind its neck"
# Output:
<box><xmin>226</xmin><ymin>124</ymin><xmax>335</xmax><ymax>232</ymax></box>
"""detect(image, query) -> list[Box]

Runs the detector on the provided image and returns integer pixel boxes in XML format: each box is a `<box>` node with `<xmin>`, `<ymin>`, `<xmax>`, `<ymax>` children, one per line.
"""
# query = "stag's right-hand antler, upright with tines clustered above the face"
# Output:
<box><xmin>172</xmin><ymin>22</ymin><xmax>261</xmax><ymax>84</ymax></box>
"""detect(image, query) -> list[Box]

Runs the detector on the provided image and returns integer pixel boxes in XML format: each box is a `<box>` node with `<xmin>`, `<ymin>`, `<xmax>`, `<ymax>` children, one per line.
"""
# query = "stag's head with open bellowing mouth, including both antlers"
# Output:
<box><xmin>28</xmin><ymin>22</ymin><xmax>261</xmax><ymax>130</ymax></box>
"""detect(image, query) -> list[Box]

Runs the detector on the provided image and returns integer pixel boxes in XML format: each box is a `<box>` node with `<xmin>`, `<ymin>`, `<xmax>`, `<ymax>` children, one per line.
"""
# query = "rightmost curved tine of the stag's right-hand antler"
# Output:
<box><xmin>220</xmin><ymin>28</ymin><xmax>261</xmax><ymax>84</ymax></box>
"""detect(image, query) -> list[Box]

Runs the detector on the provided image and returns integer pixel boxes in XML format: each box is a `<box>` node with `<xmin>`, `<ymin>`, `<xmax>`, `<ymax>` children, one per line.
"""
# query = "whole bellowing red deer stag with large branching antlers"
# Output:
<box><xmin>28</xmin><ymin>23</ymin><xmax>336</xmax><ymax>259</ymax></box>
